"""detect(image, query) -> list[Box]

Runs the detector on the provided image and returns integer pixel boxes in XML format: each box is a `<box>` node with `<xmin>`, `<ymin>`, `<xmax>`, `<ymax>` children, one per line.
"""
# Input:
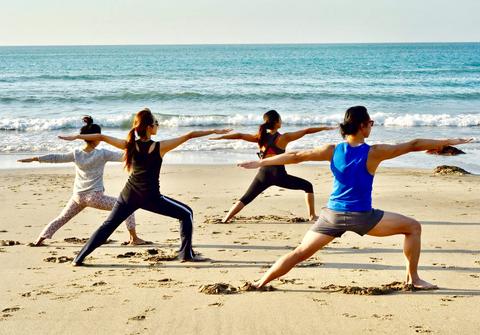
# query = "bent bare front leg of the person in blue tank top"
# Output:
<box><xmin>368</xmin><ymin>212</ymin><xmax>438</xmax><ymax>289</ymax></box>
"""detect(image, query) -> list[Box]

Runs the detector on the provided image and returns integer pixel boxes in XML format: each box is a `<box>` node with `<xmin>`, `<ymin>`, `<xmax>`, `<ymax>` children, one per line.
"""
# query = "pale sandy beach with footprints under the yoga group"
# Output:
<box><xmin>0</xmin><ymin>165</ymin><xmax>480</xmax><ymax>335</ymax></box>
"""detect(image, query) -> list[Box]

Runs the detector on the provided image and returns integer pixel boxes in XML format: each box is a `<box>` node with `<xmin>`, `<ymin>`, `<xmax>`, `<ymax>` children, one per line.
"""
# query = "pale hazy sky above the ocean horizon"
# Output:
<box><xmin>0</xmin><ymin>0</ymin><xmax>480</xmax><ymax>45</ymax></box>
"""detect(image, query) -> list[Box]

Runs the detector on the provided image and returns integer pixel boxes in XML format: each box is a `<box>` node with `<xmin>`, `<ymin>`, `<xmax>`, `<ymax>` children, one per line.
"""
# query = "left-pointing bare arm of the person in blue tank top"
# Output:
<box><xmin>238</xmin><ymin>144</ymin><xmax>335</xmax><ymax>169</ymax></box>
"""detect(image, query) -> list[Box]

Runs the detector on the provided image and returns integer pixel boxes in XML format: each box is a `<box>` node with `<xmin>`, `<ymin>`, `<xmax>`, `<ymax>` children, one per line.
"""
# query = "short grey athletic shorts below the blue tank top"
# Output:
<box><xmin>310</xmin><ymin>207</ymin><xmax>384</xmax><ymax>237</ymax></box>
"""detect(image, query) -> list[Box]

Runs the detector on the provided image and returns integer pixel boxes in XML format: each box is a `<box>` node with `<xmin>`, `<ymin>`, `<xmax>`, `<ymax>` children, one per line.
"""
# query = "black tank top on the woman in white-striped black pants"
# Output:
<box><xmin>126</xmin><ymin>140</ymin><xmax>162</xmax><ymax>194</ymax></box>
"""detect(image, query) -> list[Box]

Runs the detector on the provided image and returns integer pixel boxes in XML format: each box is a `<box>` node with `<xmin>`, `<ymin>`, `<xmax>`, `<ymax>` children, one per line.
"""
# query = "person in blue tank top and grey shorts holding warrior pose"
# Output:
<box><xmin>240</xmin><ymin>106</ymin><xmax>471</xmax><ymax>289</ymax></box>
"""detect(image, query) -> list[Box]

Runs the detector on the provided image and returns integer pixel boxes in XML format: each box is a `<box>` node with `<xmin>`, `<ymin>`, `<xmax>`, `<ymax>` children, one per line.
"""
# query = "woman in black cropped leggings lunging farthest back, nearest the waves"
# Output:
<box><xmin>211</xmin><ymin>110</ymin><xmax>336</xmax><ymax>223</ymax></box>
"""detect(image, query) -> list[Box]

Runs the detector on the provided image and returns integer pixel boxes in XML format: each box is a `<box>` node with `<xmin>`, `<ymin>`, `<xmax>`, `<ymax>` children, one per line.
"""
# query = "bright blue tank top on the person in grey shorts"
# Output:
<box><xmin>327</xmin><ymin>142</ymin><xmax>373</xmax><ymax>212</ymax></box>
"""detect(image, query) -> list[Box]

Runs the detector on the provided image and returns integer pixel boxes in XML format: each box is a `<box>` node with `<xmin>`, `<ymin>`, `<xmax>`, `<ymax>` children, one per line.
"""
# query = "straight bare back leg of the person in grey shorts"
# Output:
<box><xmin>254</xmin><ymin>230</ymin><xmax>335</xmax><ymax>287</ymax></box>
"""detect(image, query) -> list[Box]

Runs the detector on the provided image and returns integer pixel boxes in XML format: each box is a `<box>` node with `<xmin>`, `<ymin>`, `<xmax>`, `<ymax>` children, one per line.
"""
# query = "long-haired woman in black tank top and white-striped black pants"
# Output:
<box><xmin>60</xmin><ymin>108</ymin><xmax>230</xmax><ymax>265</ymax></box>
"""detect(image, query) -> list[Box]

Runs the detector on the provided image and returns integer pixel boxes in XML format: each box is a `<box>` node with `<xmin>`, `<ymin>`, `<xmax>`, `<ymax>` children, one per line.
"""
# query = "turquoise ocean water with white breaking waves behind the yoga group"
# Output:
<box><xmin>0</xmin><ymin>43</ymin><xmax>480</xmax><ymax>173</ymax></box>
